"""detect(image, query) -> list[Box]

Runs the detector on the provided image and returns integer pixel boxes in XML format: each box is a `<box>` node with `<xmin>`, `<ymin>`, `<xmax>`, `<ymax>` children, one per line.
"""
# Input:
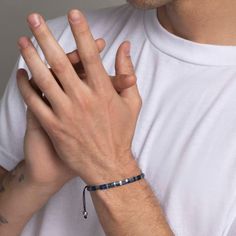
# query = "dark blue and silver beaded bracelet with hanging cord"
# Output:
<box><xmin>83</xmin><ymin>173</ymin><xmax>144</xmax><ymax>219</ymax></box>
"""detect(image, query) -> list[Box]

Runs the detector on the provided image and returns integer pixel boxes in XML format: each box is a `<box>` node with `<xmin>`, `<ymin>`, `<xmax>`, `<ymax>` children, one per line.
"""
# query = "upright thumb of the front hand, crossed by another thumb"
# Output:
<box><xmin>115</xmin><ymin>41</ymin><xmax>141</xmax><ymax>105</ymax></box>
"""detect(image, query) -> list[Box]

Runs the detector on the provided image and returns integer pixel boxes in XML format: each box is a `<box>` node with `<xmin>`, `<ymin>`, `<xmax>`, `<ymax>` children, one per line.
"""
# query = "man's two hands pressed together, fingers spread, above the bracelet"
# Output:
<box><xmin>17</xmin><ymin>10</ymin><xmax>142</xmax><ymax>190</ymax></box>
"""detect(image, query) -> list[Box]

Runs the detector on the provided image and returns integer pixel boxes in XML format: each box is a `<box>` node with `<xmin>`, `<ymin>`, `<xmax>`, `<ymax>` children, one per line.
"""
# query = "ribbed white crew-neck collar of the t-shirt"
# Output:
<box><xmin>144</xmin><ymin>9</ymin><xmax>236</xmax><ymax>66</ymax></box>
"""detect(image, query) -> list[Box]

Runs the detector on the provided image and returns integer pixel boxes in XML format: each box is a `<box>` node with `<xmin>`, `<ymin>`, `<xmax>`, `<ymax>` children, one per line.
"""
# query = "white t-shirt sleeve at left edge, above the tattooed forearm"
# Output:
<box><xmin>0</xmin><ymin>60</ymin><xmax>26</xmax><ymax>171</ymax></box>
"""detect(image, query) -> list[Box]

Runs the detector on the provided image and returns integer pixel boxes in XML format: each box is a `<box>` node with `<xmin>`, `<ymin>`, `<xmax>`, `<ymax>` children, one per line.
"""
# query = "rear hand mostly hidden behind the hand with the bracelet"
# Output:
<box><xmin>21</xmin><ymin>39</ymin><xmax>138</xmax><ymax>188</ymax></box>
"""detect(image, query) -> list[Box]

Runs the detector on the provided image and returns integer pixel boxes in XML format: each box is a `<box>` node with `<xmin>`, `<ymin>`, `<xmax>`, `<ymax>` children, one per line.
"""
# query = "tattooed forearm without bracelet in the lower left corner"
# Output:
<box><xmin>0</xmin><ymin>163</ymin><xmax>57</xmax><ymax>236</ymax></box>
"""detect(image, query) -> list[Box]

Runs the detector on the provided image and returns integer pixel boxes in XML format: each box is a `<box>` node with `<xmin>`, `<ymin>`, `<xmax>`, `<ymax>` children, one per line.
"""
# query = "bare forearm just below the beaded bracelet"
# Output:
<box><xmin>91</xmin><ymin>159</ymin><xmax>173</xmax><ymax>236</ymax></box>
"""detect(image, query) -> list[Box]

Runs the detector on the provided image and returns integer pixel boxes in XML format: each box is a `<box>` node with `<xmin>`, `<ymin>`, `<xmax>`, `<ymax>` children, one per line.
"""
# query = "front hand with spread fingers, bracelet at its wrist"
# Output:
<box><xmin>18</xmin><ymin>11</ymin><xmax>141</xmax><ymax>184</ymax></box>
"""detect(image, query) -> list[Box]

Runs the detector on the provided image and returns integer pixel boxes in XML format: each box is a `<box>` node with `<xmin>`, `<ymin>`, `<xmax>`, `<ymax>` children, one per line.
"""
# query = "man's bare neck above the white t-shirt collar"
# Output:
<box><xmin>157</xmin><ymin>0</ymin><xmax>236</xmax><ymax>45</ymax></box>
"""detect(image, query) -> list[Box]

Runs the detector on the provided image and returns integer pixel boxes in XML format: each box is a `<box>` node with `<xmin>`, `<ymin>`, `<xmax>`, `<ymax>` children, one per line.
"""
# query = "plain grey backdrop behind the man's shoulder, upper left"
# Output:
<box><xmin>0</xmin><ymin>0</ymin><xmax>126</xmax><ymax>98</ymax></box>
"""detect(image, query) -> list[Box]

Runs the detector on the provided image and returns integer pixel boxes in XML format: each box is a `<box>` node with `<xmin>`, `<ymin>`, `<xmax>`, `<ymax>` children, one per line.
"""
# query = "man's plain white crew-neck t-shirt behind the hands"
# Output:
<box><xmin>0</xmin><ymin>4</ymin><xmax>236</xmax><ymax>236</ymax></box>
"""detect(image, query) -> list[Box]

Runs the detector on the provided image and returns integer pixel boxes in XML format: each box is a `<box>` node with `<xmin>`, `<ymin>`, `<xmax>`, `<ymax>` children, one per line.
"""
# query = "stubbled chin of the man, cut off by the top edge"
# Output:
<box><xmin>126</xmin><ymin>0</ymin><xmax>173</xmax><ymax>9</ymax></box>
